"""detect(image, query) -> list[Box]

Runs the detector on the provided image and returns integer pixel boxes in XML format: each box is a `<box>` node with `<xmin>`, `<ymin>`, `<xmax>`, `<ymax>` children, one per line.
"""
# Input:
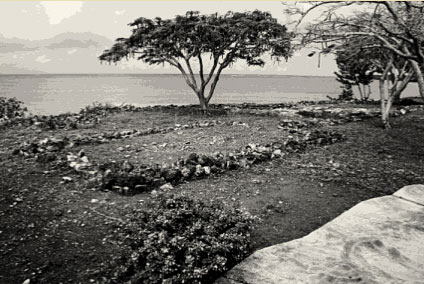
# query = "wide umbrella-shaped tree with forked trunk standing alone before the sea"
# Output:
<box><xmin>99</xmin><ymin>11</ymin><xmax>292</xmax><ymax>111</ymax></box>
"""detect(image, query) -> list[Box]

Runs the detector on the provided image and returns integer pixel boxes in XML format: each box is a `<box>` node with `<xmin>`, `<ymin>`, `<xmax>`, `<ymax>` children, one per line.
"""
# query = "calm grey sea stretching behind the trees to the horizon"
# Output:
<box><xmin>0</xmin><ymin>74</ymin><xmax>417</xmax><ymax>114</ymax></box>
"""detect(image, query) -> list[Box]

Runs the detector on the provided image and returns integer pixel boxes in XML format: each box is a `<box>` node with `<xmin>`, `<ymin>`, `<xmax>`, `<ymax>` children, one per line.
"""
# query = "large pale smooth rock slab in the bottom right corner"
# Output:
<box><xmin>216</xmin><ymin>186</ymin><xmax>424</xmax><ymax>284</ymax></box>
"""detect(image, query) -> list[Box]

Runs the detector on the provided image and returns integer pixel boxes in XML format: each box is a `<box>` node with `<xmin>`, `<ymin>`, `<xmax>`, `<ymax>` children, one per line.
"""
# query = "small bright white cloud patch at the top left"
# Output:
<box><xmin>40</xmin><ymin>1</ymin><xmax>83</xmax><ymax>25</ymax></box>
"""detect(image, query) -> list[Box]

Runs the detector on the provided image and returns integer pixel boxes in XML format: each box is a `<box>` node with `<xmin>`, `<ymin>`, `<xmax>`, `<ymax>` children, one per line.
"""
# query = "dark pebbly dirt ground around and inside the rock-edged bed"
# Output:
<box><xmin>0</xmin><ymin>105</ymin><xmax>424</xmax><ymax>283</ymax></box>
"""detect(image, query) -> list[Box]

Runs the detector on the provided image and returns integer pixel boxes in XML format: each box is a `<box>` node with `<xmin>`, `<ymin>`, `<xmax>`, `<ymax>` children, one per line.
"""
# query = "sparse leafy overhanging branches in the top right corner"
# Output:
<box><xmin>286</xmin><ymin>1</ymin><xmax>424</xmax><ymax>98</ymax></box>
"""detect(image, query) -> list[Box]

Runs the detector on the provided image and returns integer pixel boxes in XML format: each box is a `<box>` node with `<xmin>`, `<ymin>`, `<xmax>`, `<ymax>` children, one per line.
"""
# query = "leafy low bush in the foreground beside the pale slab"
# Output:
<box><xmin>105</xmin><ymin>195</ymin><xmax>253</xmax><ymax>283</ymax></box>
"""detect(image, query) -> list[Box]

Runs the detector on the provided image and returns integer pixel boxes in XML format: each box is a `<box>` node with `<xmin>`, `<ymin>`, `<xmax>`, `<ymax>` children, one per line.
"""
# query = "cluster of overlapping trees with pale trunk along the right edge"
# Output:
<box><xmin>285</xmin><ymin>1</ymin><xmax>424</xmax><ymax>128</ymax></box>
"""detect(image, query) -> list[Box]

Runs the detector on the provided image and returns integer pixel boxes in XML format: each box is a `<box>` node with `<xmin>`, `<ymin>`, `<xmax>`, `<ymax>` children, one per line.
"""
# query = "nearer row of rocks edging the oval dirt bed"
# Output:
<box><xmin>91</xmin><ymin>131</ymin><xmax>345</xmax><ymax>195</ymax></box>
